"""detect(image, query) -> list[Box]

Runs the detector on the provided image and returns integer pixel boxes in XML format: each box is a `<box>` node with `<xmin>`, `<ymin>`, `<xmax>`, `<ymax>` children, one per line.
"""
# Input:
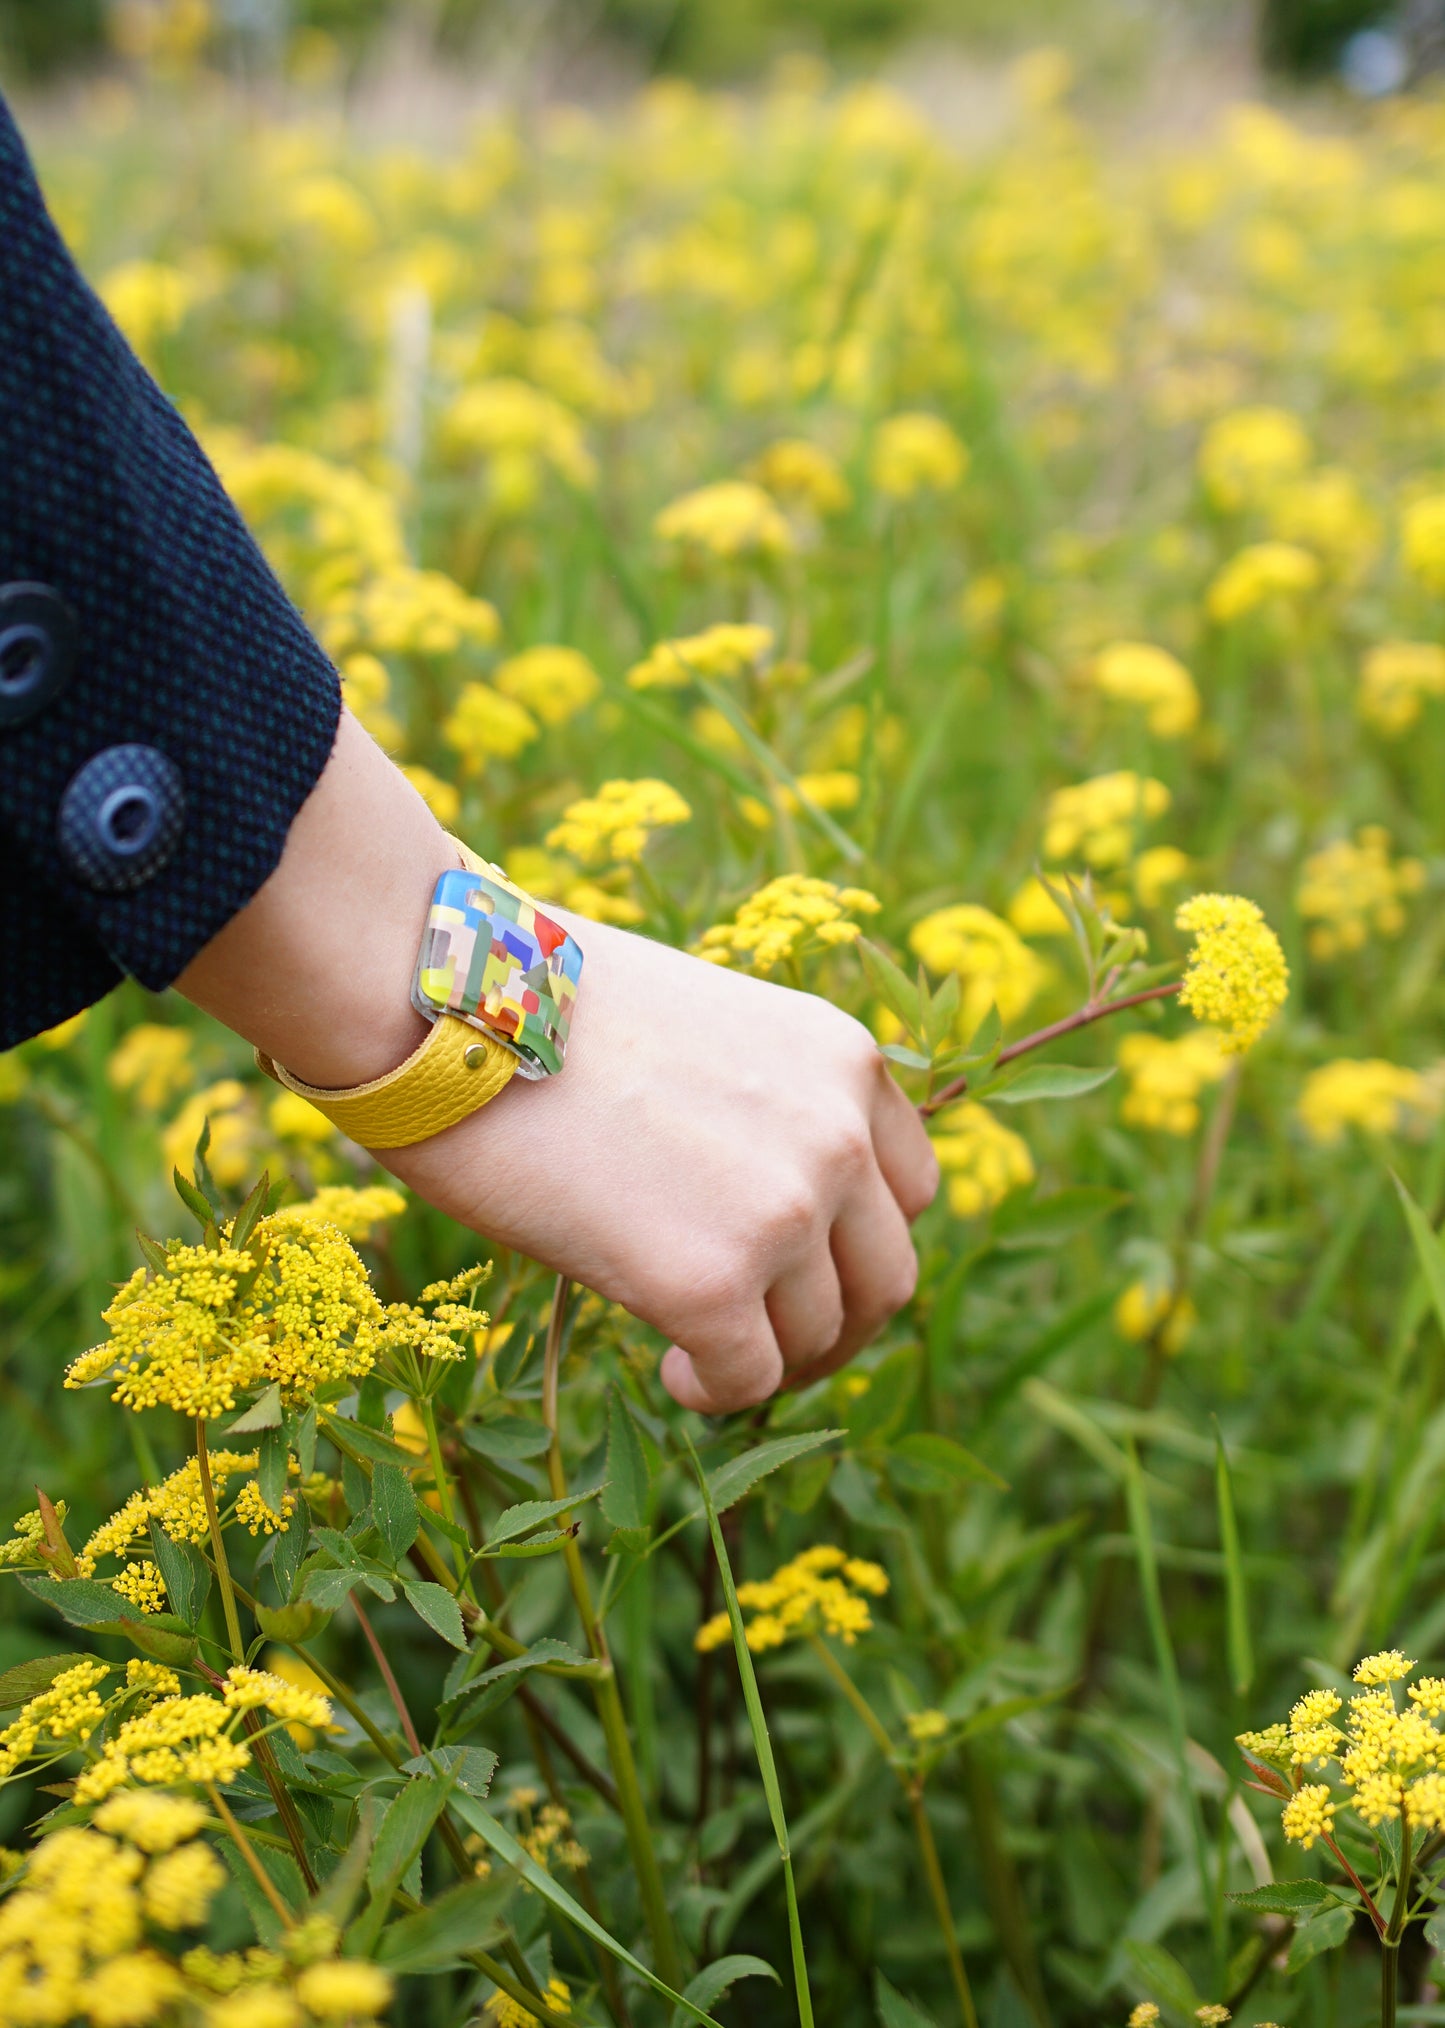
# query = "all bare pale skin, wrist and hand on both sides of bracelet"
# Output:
<box><xmin>176</xmin><ymin>712</ymin><xmax>938</xmax><ymax>1414</ymax></box>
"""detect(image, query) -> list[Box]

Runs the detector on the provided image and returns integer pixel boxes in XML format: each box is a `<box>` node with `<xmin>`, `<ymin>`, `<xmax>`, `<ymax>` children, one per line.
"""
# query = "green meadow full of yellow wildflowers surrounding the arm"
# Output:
<box><xmin>0</xmin><ymin>27</ymin><xmax>1445</xmax><ymax>2028</ymax></box>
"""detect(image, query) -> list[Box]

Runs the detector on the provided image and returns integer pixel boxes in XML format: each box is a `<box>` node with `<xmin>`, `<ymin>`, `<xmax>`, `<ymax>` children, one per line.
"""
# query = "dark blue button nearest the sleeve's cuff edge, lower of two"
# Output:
<box><xmin>57</xmin><ymin>746</ymin><xmax>186</xmax><ymax>894</ymax></box>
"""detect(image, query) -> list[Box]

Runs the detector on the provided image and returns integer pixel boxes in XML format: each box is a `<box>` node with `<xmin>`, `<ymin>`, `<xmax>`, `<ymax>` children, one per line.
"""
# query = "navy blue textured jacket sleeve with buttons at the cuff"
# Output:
<box><xmin>0</xmin><ymin>101</ymin><xmax>340</xmax><ymax>1048</ymax></box>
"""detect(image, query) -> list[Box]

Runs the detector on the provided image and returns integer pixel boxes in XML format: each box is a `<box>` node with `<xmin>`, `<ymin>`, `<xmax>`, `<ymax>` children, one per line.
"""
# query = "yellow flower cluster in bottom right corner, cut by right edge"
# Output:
<box><xmin>1238</xmin><ymin>1649</ymin><xmax>1445</xmax><ymax>1850</ymax></box>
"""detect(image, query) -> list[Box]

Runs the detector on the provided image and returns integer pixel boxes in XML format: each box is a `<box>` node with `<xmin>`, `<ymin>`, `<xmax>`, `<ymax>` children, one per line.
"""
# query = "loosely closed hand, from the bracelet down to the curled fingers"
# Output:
<box><xmin>379</xmin><ymin>911</ymin><xmax>938</xmax><ymax>1414</ymax></box>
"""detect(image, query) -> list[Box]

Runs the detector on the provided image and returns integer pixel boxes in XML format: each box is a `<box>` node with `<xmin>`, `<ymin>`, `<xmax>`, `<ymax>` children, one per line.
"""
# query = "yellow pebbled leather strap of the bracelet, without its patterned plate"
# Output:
<box><xmin>255</xmin><ymin>840</ymin><xmax>517</xmax><ymax>1148</ymax></box>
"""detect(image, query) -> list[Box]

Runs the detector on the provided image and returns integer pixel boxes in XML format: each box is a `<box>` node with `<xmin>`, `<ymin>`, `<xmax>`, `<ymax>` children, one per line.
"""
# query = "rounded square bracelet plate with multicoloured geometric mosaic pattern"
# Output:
<box><xmin>411</xmin><ymin>866</ymin><xmax>582</xmax><ymax>1077</ymax></box>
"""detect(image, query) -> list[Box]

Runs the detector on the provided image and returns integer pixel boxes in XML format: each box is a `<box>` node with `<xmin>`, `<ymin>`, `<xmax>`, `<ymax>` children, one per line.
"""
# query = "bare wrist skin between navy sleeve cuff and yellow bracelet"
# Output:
<box><xmin>176</xmin><ymin>712</ymin><xmax>456</xmax><ymax>1087</ymax></box>
